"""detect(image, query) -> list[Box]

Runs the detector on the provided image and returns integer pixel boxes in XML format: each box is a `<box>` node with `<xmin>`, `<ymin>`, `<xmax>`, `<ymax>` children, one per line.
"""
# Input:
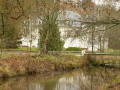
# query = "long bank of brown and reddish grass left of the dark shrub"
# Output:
<box><xmin>0</xmin><ymin>54</ymin><xmax>85</xmax><ymax>77</ymax></box>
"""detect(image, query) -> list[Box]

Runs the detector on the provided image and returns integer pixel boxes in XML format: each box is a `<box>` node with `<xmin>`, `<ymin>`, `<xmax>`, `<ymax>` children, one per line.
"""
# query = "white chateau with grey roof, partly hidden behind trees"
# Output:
<box><xmin>21</xmin><ymin>0</ymin><xmax>108</xmax><ymax>51</ymax></box>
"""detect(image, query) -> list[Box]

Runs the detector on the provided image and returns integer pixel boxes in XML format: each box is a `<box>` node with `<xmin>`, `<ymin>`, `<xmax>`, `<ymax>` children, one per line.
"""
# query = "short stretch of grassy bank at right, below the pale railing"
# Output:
<box><xmin>86</xmin><ymin>55</ymin><xmax>120</xmax><ymax>68</ymax></box>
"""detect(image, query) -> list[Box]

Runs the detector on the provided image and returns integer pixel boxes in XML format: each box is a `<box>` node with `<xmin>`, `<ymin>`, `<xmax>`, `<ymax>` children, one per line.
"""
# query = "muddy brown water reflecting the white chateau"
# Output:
<box><xmin>0</xmin><ymin>68</ymin><xmax>120</xmax><ymax>90</ymax></box>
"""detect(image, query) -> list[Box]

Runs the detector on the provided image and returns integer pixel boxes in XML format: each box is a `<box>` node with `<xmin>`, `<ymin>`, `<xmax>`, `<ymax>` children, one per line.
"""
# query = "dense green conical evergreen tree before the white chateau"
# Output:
<box><xmin>40</xmin><ymin>14</ymin><xmax>64</xmax><ymax>52</ymax></box>
